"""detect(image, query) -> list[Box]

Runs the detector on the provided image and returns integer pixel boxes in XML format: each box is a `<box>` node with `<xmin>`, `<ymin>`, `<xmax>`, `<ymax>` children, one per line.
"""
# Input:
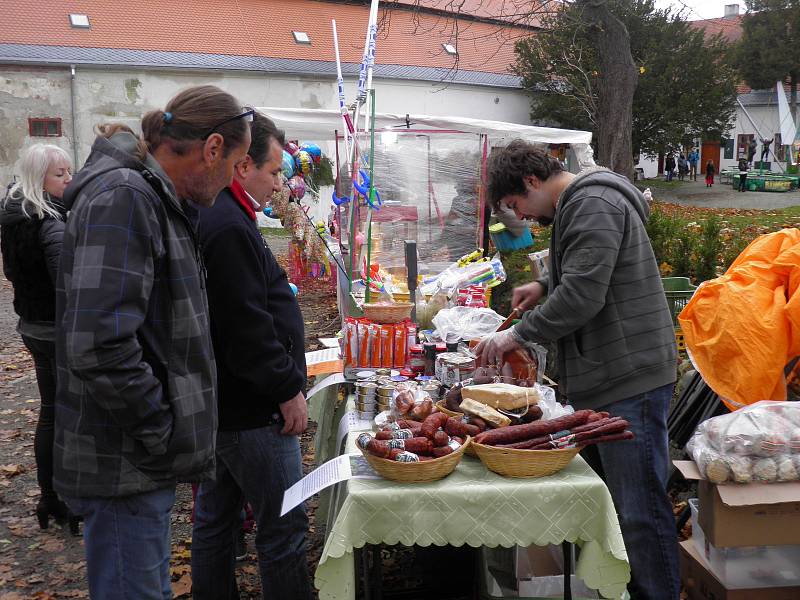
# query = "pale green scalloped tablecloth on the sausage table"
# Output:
<box><xmin>315</xmin><ymin>424</ymin><xmax>630</xmax><ymax>600</ymax></box>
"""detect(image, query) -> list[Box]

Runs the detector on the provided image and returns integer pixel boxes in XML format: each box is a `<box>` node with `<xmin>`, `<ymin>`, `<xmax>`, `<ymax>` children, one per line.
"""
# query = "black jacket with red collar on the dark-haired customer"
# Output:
<box><xmin>197</xmin><ymin>182</ymin><xmax>306</xmax><ymax>430</ymax></box>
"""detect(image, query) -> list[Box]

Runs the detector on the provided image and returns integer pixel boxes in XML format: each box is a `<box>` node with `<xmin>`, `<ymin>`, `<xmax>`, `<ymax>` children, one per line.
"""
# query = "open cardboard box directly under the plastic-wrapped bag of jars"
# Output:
<box><xmin>673</xmin><ymin>460</ymin><xmax>800</xmax><ymax>548</ymax></box>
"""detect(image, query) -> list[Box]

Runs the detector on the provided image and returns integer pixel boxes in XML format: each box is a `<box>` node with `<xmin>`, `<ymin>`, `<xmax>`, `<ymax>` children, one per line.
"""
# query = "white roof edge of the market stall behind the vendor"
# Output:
<box><xmin>258</xmin><ymin>107</ymin><xmax>592</xmax><ymax>146</ymax></box>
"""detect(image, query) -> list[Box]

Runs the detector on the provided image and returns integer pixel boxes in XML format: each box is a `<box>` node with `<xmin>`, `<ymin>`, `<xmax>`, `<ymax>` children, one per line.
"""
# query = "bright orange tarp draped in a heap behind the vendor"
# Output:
<box><xmin>678</xmin><ymin>229</ymin><xmax>800</xmax><ymax>410</ymax></box>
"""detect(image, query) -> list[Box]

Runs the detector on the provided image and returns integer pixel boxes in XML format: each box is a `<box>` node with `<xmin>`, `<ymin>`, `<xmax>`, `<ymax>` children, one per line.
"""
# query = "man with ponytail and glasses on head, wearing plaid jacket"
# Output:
<box><xmin>54</xmin><ymin>86</ymin><xmax>252</xmax><ymax>600</ymax></box>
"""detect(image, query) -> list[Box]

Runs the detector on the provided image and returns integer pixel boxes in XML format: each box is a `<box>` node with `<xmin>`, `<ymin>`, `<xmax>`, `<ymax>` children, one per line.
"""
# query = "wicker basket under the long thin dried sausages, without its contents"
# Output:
<box><xmin>471</xmin><ymin>442</ymin><xmax>580</xmax><ymax>477</ymax></box>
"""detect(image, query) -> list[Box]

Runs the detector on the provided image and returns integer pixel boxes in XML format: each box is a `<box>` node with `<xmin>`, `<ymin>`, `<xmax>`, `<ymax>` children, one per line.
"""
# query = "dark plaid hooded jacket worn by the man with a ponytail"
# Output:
<box><xmin>54</xmin><ymin>133</ymin><xmax>217</xmax><ymax>497</ymax></box>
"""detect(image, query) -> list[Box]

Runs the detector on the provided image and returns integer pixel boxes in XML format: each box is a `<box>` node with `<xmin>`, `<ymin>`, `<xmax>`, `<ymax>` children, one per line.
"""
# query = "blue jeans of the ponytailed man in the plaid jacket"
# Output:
<box><xmin>64</xmin><ymin>487</ymin><xmax>175</xmax><ymax>600</ymax></box>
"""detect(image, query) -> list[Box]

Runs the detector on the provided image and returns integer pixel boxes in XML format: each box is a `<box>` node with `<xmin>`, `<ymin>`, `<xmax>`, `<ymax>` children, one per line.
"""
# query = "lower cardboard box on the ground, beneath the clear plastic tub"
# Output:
<box><xmin>680</xmin><ymin>540</ymin><xmax>800</xmax><ymax>600</ymax></box>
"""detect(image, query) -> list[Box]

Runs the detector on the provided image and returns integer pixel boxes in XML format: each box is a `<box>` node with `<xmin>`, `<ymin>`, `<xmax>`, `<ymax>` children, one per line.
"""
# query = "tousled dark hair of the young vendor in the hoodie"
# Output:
<box><xmin>488</xmin><ymin>140</ymin><xmax>565</xmax><ymax>211</ymax></box>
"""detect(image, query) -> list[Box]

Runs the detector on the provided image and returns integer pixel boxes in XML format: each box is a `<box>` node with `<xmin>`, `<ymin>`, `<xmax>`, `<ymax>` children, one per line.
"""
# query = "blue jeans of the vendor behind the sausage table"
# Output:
<box><xmin>584</xmin><ymin>384</ymin><xmax>680</xmax><ymax>600</ymax></box>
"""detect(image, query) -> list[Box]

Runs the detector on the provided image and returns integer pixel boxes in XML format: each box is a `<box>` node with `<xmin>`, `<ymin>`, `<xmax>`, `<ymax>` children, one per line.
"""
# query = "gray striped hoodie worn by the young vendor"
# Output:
<box><xmin>514</xmin><ymin>169</ymin><xmax>676</xmax><ymax>409</ymax></box>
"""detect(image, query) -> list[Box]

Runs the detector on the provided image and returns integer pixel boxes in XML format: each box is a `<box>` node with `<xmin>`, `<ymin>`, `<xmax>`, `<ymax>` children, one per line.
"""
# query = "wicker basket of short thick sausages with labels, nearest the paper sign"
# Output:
<box><xmin>356</xmin><ymin>412</ymin><xmax>471</xmax><ymax>483</ymax></box>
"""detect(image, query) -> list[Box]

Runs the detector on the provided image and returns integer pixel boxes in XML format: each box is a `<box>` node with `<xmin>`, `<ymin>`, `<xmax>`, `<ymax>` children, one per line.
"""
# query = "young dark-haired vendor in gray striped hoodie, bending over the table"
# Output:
<box><xmin>476</xmin><ymin>140</ymin><xmax>680</xmax><ymax>600</ymax></box>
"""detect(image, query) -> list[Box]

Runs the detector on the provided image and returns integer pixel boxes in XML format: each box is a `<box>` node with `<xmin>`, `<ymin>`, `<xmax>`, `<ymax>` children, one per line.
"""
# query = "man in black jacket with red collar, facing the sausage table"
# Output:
<box><xmin>192</xmin><ymin>113</ymin><xmax>311</xmax><ymax>600</ymax></box>
